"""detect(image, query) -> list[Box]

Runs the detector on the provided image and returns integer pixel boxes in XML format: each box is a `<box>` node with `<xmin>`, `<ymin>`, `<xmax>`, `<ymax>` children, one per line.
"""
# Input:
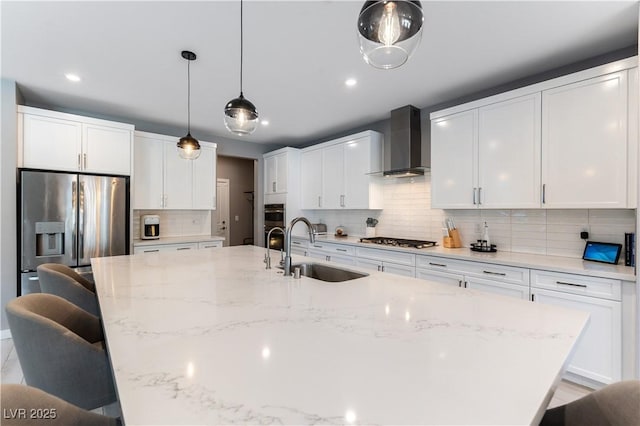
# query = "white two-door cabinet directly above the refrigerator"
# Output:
<box><xmin>18</xmin><ymin>106</ymin><xmax>133</xmax><ymax>175</ymax></box>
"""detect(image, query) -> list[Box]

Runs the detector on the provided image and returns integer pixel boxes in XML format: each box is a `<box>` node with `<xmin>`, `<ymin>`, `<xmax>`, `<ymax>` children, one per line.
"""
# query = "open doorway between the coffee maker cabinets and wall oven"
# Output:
<box><xmin>212</xmin><ymin>155</ymin><xmax>255</xmax><ymax>246</ymax></box>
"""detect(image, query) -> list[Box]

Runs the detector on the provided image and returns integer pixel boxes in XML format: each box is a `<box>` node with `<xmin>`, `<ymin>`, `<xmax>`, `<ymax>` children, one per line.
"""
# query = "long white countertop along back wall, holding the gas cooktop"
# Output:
<box><xmin>294</xmin><ymin>235</ymin><xmax>636</xmax><ymax>282</ymax></box>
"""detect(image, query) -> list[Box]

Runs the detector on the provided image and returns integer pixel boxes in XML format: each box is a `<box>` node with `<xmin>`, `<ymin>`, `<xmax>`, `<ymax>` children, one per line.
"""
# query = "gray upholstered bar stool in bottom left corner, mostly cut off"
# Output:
<box><xmin>0</xmin><ymin>384</ymin><xmax>121</xmax><ymax>426</ymax></box>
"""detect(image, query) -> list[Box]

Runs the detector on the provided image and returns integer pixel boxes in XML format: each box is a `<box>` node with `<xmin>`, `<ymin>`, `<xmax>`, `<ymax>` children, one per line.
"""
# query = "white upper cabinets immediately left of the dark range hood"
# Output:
<box><xmin>301</xmin><ymin>131</ymin><xmax>382</xmax><ymax>210</ymax></box>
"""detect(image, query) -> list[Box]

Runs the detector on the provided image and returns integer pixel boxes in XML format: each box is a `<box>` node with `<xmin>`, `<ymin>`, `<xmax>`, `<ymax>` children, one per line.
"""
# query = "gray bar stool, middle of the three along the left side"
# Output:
<box><xmin>6</xmin><ymin>293</ymin><xmax>116</xmax><ymax>410</ymax></box>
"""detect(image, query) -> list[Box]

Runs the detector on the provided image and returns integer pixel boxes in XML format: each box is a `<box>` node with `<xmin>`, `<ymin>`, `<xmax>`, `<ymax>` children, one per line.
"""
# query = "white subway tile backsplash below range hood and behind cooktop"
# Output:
<box><xmin>303</xmin><ymin>175</ymin><xmax>636</xmax><ymax>258</ymax></box>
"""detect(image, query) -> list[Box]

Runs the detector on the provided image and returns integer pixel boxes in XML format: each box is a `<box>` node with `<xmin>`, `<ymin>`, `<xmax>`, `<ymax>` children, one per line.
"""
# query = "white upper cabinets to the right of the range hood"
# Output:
<box><xmin>431</xmin><ymin>58</ymin><xmax>638</xmax><ymax>209</ymax></box>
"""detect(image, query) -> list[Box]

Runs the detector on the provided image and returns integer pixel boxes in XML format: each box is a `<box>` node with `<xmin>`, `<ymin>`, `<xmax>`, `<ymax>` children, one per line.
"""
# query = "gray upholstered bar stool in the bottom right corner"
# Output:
<box><xmin>540</xmin><ymin>380</ymin><xmax>640</xmax><ymax>426</ymax></box>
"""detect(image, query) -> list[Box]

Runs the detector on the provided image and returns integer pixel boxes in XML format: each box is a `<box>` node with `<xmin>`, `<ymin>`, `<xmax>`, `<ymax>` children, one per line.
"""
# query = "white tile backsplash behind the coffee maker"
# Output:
<box><xmin>131</xmin><ymin>210</ymin><xmax>211</xmax><ymax>239</ymax></box>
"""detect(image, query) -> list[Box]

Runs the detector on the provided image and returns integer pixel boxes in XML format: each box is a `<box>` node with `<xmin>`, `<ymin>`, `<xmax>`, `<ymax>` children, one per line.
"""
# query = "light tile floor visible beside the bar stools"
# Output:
<box><xmin>0</xmin><ymin>339</ymin><xmax>592</xmax><ymax>414</ymax></box>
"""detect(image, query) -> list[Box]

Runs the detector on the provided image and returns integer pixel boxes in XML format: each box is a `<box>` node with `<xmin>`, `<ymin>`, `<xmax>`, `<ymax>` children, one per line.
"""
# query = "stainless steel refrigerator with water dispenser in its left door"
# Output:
<box><xmin>18</xmin><ymin>169</ymin><xmax>129</xmax><ymax>295</ymax></box>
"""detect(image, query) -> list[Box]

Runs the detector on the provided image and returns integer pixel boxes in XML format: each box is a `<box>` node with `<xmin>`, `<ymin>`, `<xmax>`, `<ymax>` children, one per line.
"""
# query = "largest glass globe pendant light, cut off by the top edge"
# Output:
<box><xmin>358</xmin><ymin>0</ymin><xmax>424</xmax><ymax>69</ymax></box>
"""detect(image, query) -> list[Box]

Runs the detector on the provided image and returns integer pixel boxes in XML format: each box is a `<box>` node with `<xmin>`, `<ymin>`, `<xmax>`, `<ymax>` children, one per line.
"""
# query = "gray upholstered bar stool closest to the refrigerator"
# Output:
<box><xmin>37</xmin><ymin>263</ymin><xmax>100</xmax><ymax>316</ymax></box>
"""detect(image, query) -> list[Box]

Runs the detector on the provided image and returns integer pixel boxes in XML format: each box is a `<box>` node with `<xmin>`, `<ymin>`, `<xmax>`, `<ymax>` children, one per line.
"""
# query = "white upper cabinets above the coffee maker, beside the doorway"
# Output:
<box><xmin>133</xmin><ymin>132</ymin><xmax>217</xmax><ymax>210</ymax></box>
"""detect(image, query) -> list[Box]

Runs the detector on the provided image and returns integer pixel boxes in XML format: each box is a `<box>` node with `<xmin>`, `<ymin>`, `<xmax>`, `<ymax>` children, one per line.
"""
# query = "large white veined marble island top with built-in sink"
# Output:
<box><xmin>92</xmin><ymin>246</ymin><xmax>588</xmax><ymax>425</ymax></box>
